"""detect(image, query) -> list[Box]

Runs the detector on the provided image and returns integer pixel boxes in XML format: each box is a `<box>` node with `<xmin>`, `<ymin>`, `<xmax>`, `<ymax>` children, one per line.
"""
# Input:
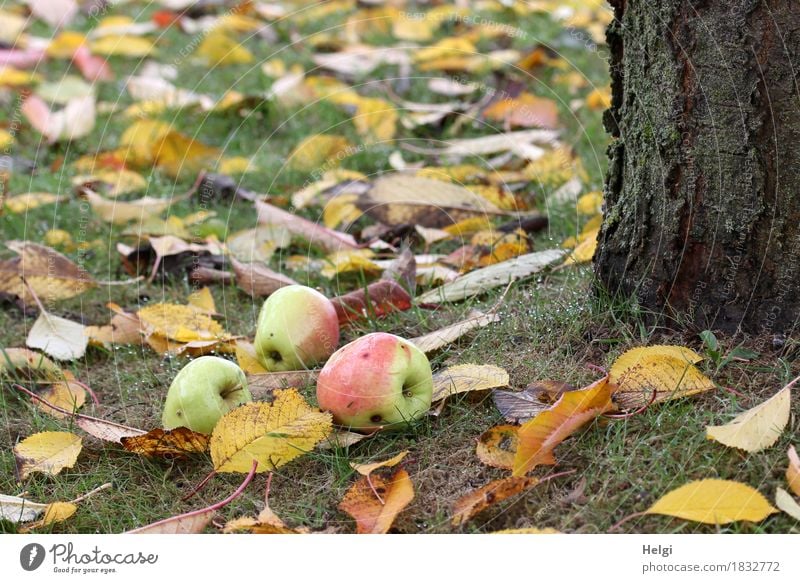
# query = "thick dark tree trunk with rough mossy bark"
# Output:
<box><xmin>595</xmin><ymin>0</ymin><xmax>800</xmax><ymax>334</ymax></box>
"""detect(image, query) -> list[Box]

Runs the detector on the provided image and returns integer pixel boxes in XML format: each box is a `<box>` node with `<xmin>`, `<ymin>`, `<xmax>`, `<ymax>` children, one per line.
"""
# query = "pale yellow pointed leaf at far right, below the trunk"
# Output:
<box><xmin>706</xmin><ymin>387</ymin><xmax>792</xmax><ymax>453</ymax></box>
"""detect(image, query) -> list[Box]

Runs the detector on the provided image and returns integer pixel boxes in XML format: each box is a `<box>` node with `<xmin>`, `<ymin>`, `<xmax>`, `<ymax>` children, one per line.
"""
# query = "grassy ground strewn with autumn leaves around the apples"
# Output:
<box><xmin>0</xmin><ymin>0</ymin><xmax>800</xmax><ymax>533</ymax></box>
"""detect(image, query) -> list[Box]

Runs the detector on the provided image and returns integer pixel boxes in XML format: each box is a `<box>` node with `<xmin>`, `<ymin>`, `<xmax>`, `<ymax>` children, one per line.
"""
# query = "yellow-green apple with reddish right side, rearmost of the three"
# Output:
<box><xmin>253</xmin><ymin>285</ymin><xmax>339</xmax><ymax>371</ymax></box>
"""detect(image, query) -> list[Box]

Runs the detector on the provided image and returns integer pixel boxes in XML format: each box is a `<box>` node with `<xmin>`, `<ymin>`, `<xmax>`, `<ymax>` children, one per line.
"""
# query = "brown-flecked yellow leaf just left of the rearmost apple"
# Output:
<box><xmin>138</xmin><ymin>304</ymin><xmax>230</xmax><ymax>342</ymax></box>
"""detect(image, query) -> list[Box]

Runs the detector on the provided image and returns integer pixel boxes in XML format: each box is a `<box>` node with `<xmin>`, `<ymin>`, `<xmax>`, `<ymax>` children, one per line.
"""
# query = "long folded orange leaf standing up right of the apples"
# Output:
<box><xmin>514</xmin><ymin>377</ymin><xmax>613</xmax><ymax>476</ymax></box>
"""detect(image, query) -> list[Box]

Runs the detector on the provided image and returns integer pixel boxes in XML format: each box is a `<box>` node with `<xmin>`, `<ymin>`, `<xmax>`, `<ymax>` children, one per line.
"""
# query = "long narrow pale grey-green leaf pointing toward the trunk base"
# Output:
<box><xmin>417</xmin><ymin>249</ymin><xmax>564</xmax><ymax>304</ymax></box>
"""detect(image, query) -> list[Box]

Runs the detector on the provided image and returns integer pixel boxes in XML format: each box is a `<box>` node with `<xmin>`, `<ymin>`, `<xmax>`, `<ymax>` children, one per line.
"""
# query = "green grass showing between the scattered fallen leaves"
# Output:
<box><xmin>0</xmin><ymin>6</ymin><xmax>800</xmax><ymax>533</ymax></box>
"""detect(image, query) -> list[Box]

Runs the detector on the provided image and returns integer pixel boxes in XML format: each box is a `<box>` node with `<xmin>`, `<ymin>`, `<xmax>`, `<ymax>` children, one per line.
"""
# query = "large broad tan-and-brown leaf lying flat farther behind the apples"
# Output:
<box><xmin>358</xmin><ymin>174</ymin><xmax>505</xmax><ymax>227</ymax></box>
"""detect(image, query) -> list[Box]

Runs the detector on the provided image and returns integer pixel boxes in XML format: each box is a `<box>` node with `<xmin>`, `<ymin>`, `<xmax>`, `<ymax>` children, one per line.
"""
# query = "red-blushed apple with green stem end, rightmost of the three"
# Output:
<box><xmin>317</xmin><ymin>332</ymin><xmax>433</xmax><ymax>432</ymax></box>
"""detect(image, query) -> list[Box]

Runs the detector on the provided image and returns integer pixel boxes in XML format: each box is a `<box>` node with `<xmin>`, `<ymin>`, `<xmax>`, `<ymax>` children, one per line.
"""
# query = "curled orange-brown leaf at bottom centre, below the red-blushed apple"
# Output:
<box><xmin>339</xmin><ymin>468</ymin><xmax>414</xmax><ymax>534</ymax></box>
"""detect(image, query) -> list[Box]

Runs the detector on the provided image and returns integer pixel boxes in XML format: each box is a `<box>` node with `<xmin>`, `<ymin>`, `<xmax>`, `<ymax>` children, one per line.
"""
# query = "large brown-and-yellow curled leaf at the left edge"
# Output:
<box><xmin>0</xmin><ymin>241</ymin><xmax>97</xmax><ymax>303</ymax></box>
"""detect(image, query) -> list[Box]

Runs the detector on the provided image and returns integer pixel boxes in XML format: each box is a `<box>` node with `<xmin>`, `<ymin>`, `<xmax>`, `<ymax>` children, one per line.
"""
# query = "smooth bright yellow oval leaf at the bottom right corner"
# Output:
<box><xmin>645</xmin><ymin>479</ymin><xmax>777</xmax><ymax>525</ymax></box>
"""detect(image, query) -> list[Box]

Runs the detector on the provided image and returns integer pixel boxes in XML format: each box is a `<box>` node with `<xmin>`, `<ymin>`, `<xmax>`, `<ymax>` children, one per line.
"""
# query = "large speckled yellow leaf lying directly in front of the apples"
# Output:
<box><xmin>210</xmin><ymin>389</ymin><xmax>331</xmax><ymax>473</ymax></box>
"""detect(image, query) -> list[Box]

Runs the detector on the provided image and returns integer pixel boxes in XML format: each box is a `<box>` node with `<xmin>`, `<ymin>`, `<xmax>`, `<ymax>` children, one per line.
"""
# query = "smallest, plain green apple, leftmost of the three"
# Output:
<box><xmin>162</xmin><ymin>356</ymin><xmax>253</xmax><ymax>433</ymax></box>
